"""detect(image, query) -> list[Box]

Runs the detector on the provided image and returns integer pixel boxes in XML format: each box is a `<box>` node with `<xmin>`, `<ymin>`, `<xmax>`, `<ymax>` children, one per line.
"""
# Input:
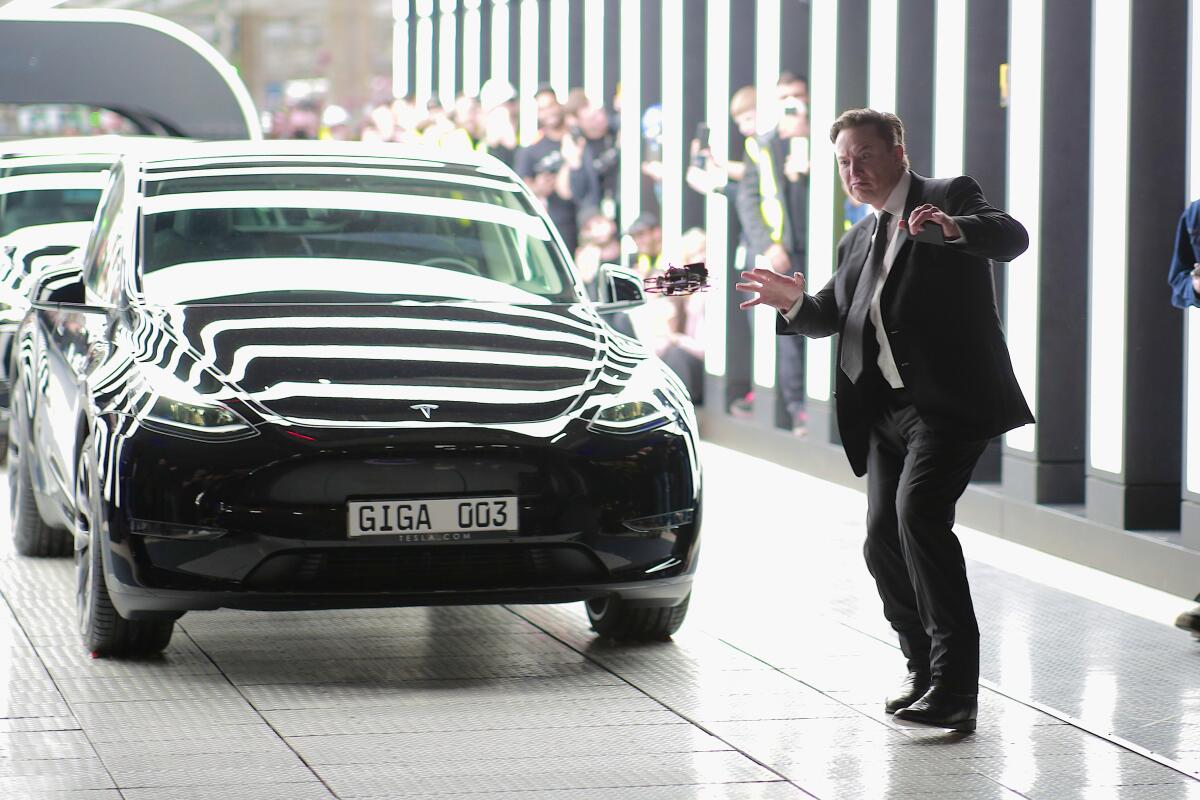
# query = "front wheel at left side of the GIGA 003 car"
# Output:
<box><xmin>74</xmin><ymin>437</ymin><xmax>175</xmax><ymax>656</ymax></box>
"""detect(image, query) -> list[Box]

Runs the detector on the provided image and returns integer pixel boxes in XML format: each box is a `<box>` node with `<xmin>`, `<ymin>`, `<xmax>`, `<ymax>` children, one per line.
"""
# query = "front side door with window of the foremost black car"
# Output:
<box><xmin>34</xmin><ymin>168</ymin><xmax>127</xmax><ymax>509</ymax></box>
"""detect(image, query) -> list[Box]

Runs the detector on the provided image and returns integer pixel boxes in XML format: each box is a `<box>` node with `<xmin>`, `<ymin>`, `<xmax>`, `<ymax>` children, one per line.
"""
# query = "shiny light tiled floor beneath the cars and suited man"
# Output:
<box><xmin>0</xmin><ymin>446</ymin><xmax>1200</xmax><ymax>800</ymax></box>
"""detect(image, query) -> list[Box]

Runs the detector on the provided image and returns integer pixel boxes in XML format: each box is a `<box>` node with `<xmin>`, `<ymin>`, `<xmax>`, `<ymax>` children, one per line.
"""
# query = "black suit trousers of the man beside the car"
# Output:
<box><xmin>863</xmin><ymin>388</ymin><xmax>986</xmax><ymax>694</ymax></box>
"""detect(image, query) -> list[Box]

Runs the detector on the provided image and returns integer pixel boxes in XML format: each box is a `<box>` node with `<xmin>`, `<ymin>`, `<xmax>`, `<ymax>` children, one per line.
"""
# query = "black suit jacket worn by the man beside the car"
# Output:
<box><xmin>778</xmin><ymin>173</ymin><xmax>1033</xmax><ymax>475</ymax></box>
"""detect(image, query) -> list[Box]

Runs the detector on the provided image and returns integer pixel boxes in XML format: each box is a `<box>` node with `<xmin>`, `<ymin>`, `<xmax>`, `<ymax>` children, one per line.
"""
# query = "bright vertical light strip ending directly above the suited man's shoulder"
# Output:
<box><xmin>934</xmin><ymin>0</ymin><xmax>969</xmax><ymax>178</ymax></box>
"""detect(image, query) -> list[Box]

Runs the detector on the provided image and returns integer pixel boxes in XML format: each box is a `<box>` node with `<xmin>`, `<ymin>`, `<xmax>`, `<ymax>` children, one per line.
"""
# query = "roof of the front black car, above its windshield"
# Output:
<box><xmin>126</xmin><ymin>139</ymin><xmax>516</xmax><ymax>180</ymax></box>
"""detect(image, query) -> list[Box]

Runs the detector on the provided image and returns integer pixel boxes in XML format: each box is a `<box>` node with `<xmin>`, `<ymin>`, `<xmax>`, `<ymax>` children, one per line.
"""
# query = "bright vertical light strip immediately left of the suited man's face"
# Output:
<box><xmin>804</xmin><ymin>0</ymin><xmax>839</xmax><ymax>402</ymax></box>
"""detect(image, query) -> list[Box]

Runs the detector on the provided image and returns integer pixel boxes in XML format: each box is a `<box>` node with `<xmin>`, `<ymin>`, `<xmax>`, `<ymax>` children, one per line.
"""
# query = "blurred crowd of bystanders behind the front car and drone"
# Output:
<box><xmin>270</xmin><ymin>72</ymin><xmax>809</xmax><ymax>419</ymax></box>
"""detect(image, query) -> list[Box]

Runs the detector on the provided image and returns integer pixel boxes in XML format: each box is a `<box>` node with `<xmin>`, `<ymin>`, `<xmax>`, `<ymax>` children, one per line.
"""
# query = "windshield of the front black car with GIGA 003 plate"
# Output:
<box><xmin>140</xmin><ymin>166</ymin><xmax>578</xmax><ymax>306</ymax></box>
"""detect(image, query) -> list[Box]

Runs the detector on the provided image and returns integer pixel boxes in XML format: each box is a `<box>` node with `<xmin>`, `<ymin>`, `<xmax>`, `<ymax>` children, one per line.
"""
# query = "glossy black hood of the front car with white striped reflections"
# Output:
<box><xmin>147</xmin><ymin>303</ymin><xmax>629</xmax><ymax>427</ymax></box>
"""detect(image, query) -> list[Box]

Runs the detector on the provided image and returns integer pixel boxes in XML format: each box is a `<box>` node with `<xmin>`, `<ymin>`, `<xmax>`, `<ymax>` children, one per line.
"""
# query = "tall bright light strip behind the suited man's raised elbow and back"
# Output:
<box><xmin>1003</xmin><ymin>0</ymin><xmax>1045</xmax><ymax>453</ymax></box>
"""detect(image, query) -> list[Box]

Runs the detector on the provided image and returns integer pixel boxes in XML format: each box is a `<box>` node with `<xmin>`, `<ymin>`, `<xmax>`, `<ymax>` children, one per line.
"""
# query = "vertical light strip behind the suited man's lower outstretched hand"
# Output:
<box><xmin>750</xmin><ymin>0</ymin><xmax>782</xmax><ymax>387</ymax></box>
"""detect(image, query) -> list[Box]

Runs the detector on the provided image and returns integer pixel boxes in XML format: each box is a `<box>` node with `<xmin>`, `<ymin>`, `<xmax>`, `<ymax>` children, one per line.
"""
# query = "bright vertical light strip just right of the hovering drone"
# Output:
<box><xmin>704</xmin><ymin>0</ymin><xmax>737</xmax><ymax>375</ymax></box>
